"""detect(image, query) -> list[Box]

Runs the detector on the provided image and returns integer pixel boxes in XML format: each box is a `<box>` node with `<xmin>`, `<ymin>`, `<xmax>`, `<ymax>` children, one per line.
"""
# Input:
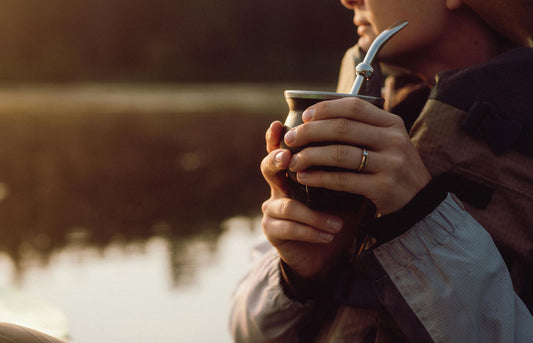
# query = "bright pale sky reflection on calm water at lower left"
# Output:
<box><xmin>9</xmin><ymin>217</ymin><xmax>260</xmax><ymax>343</ymax></box>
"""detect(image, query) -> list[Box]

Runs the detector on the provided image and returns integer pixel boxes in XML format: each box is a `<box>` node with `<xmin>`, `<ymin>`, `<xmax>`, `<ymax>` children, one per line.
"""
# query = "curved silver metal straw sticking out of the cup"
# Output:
<box><xmin>350</xmin><ymin>20</ymin><xmax>407</xmax><ymax>95</ymax></box>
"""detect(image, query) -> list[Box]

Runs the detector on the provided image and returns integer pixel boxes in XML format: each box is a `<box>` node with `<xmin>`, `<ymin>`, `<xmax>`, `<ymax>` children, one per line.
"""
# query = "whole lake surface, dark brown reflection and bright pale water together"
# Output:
<box><xmin>0</xmin><ymin>84</ymin><xmax>327</xmax><ymax>343</ymax></box>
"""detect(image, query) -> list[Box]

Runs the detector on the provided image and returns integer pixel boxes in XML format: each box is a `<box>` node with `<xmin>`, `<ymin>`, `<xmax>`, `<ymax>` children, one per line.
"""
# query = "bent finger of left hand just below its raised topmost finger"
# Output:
<box><xmin>261</xmin><ymin>149</ymin><xmax>291</xmax><ymax>196</ymax></box>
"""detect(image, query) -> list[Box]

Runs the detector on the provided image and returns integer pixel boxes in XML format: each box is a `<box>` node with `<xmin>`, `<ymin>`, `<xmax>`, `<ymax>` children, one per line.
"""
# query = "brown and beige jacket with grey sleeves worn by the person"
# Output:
<box><xmin>230</xmin><ymin>47</ymin><xmax>533</xmax><ymax>343</ymax></box>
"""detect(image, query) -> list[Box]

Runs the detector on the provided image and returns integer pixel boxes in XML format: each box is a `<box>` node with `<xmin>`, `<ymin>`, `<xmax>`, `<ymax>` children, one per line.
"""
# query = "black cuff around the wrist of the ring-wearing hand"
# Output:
<box><xmin>368</xmin><ymin>179</ymin><xmax>447</xmax><ymax>245</ymax></box>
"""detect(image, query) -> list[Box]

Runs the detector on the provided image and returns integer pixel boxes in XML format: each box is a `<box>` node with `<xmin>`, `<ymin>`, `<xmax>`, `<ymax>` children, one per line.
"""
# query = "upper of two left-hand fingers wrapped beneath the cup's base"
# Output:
<box><xmin>262</xmin><ymin>198</ymin><xmax>343</xmax><ymax>234</ymax></box>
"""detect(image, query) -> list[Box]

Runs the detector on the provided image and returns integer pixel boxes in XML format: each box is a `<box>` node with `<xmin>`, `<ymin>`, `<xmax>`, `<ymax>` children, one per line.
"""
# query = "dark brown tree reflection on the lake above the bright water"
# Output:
<box><xmin>0</xmin><ymin>87</ymin><xmax>284</xmax><ymax>285</ymax></box>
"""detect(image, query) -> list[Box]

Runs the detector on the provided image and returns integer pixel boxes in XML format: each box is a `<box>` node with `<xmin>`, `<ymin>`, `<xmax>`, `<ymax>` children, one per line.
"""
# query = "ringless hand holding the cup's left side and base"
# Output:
<box><xmin>261</xmin><ymin>121</ymin><xmax>354</xmax><ymax>279</ymax></box>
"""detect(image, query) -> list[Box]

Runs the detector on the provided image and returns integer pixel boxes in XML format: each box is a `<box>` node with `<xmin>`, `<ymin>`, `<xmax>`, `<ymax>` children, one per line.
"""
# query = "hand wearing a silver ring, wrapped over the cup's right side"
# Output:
<box><xmin>284</xmin><ymin>97</ymin><xmax>431</xmax><ymax>215</ymax></box>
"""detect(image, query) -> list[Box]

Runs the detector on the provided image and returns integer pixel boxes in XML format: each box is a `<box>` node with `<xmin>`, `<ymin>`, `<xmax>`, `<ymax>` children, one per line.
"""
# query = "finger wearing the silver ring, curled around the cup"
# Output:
<box><xmin>289</xmin><ymin>145</ymin><xmax>380</xmax><ymax>173</ymax></box>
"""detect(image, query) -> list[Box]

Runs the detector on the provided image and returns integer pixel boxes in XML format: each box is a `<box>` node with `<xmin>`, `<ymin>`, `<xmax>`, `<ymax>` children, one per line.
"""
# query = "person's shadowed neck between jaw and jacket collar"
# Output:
<box><xmin>382</xmin><ymin>6</ymin><xmax>513</xmax><ymax>80</ymax></box>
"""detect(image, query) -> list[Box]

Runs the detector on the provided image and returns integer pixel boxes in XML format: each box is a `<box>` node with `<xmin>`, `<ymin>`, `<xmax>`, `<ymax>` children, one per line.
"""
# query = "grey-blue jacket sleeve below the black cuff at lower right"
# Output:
<box><xmin>366</xmin><ymin>195</ymin><xmax>533</xmax><ymax>343</ymax></box>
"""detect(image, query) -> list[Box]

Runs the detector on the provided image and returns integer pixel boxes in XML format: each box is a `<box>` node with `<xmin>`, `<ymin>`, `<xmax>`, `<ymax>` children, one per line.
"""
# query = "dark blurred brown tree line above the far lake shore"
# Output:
<box><xmin>0</xmin><ymin>0</ymin><xmax>355</xmax><ymax>82</ymax></box>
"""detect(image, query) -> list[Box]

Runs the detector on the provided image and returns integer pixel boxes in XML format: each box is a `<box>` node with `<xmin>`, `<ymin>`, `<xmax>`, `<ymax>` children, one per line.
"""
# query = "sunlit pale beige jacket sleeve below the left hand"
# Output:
<box><xmin>230</xmin><ymin>239</ymin><xmax>312</xmax><ymax>343</ymax></box>
